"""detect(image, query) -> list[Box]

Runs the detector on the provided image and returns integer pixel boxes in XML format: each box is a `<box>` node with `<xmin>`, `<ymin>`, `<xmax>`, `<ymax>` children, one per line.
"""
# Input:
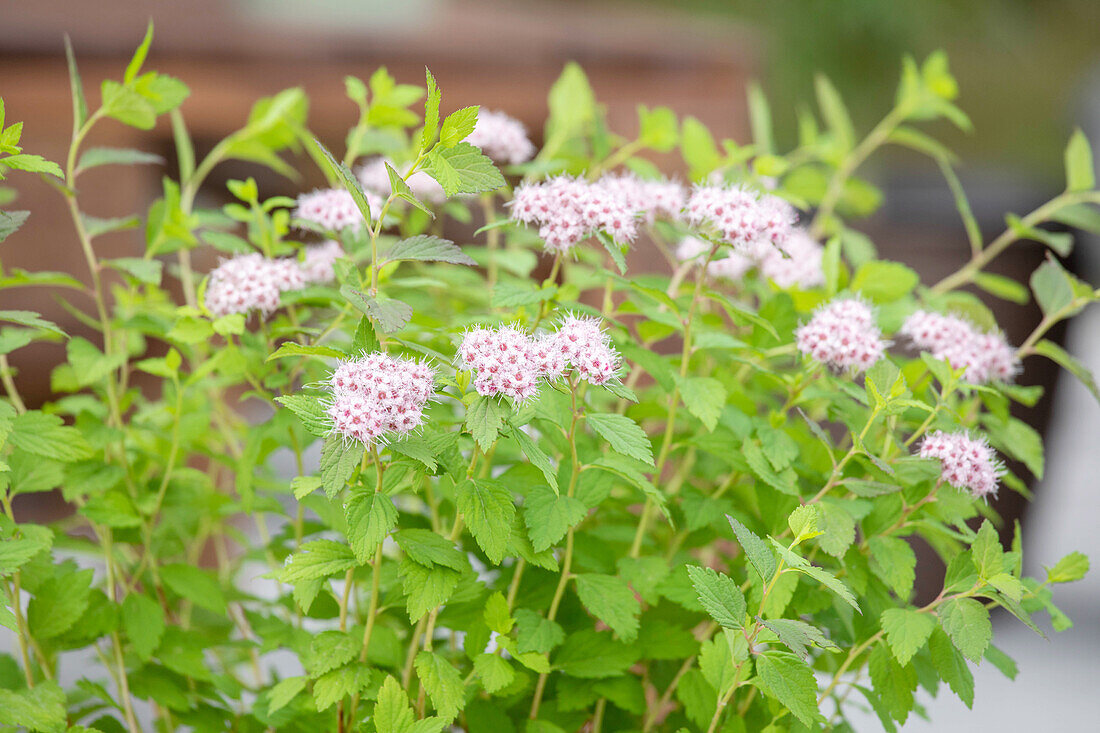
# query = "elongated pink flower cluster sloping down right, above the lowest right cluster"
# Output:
<box><xmin>899</xmin><ymin>310</ymin><xmax>1020</xmax><ymax>384</ymax></box>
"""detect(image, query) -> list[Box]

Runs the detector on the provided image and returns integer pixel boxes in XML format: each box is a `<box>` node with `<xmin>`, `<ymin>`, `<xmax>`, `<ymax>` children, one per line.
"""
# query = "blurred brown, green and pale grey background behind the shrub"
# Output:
<box><xmin>0</xmin><ymin>0</ymin><xmax>1100</xmax><ymax>731</ymax></box>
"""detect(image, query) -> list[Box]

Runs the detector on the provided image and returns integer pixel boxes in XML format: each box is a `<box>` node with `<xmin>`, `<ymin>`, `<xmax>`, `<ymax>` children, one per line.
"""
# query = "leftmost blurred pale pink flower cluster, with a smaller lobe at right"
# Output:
<box><xmin>205</xmin><ymin>241</ymin><xmax>344</xmax><ymax>316</ymax></box>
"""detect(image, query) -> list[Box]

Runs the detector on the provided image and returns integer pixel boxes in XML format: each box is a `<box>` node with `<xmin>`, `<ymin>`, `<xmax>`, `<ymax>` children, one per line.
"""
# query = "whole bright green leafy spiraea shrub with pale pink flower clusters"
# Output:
<box><xmin>0</xmin><ymin>24</ymin><xmax>1100</xmax><ymax>733</ymax></box>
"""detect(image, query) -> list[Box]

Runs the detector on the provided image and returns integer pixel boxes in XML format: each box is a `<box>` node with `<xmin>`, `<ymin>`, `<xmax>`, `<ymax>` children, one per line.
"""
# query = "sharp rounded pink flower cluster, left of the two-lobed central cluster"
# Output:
<box><xmin>328</xmin><ymin>353</ymin><xmax>436</xmax><ymax>446</ymax></box>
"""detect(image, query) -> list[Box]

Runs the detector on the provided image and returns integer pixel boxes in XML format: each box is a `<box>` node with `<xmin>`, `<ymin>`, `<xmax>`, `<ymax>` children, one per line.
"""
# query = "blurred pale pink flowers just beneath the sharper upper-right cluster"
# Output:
<box><xmin>677</xmin><ymin>229</ymin><xmax>825</xmax><ymax>289</ymax></box>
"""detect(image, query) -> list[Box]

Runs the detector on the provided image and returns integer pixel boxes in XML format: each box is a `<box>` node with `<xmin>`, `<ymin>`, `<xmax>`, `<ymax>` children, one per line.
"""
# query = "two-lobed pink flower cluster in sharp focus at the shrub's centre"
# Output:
<box><xmin>459</xmin><ymin>316</ymin><xmax>620</xmax><ymax>402</ymax></box>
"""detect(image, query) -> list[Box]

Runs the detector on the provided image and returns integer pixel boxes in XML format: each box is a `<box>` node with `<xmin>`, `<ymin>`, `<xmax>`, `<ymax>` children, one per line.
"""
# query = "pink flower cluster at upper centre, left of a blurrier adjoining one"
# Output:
<box><xmin>510</xmin><ymin>176</ymin><xmax>638</xmax><ymax>252</ymax></box>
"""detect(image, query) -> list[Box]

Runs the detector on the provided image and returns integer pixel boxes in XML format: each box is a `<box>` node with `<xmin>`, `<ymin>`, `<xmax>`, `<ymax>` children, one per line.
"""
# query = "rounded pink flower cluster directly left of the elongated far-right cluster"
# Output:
<box><xmin>794</xmin><ymin>298</ymin><xmax>887</xmax><ymax>373</ymax></box>
